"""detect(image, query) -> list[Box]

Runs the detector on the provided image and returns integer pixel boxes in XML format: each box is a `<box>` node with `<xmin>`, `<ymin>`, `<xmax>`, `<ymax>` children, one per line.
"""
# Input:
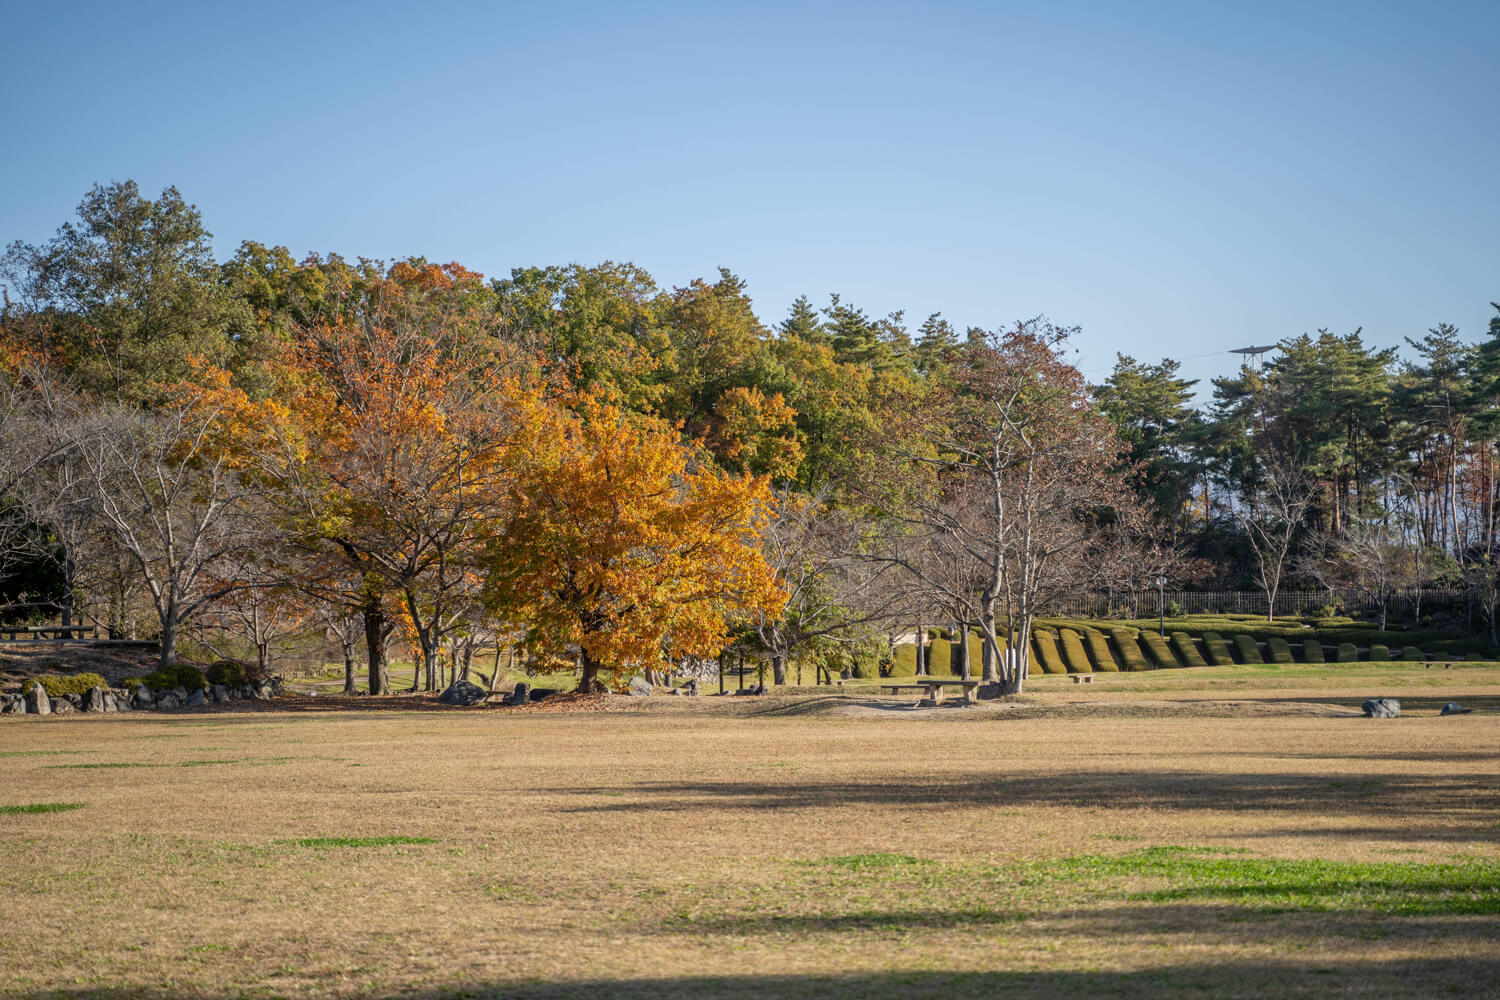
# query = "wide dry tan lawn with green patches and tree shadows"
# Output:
<box><xmin>0</xmin><ymin>667</ymin><xmax>1500</xmax><ymax>999</ymax></box>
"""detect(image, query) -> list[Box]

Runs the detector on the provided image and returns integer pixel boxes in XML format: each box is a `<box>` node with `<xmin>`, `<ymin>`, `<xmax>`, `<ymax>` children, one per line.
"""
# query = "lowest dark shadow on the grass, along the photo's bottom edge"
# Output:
<box><xmin>9</xmin><ymin>958</ymin><xmax>1500</xmax><ymax>1000</ymax></box>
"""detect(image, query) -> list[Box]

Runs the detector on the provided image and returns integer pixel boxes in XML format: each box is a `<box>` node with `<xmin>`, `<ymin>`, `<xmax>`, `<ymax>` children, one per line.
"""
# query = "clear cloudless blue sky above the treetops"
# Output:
<box><xmin>0</xmin><ymin>0</ymin><xmax>1500</xmax><ymax>398</ymax></box>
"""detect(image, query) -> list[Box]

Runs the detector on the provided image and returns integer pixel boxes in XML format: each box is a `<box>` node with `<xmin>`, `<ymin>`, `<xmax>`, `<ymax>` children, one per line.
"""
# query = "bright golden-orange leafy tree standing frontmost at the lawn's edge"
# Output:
<box><xmin>485</xmin><ymin>396</ymin><xmax>786</xmax><ymax>691</ymax></box>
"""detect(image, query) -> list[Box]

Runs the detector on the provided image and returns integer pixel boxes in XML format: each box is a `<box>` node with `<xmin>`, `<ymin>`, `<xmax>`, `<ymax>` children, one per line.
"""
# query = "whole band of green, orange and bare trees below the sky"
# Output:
<box><xmin>0</xmin><ymin>181</ymin><xmax>1500</xmax><ymax>693</ymax></box>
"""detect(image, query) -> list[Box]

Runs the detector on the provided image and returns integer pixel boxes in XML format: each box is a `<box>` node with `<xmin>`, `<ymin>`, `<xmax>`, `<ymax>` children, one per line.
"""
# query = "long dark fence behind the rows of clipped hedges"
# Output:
<box><xmin>1055</xmin><ymin>588</ymin><xmax>1470</xmax><ymax>618</ymax></box>
